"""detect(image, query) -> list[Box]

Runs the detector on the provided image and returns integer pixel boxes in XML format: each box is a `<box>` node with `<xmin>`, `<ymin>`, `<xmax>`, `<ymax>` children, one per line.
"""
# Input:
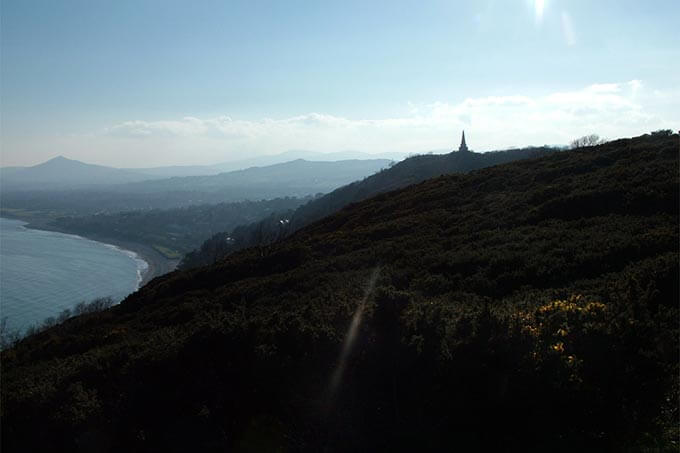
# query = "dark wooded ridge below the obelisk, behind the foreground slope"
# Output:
<box><xmin>179</xmin><ymin>146</ymin><xmax>558</xmax><ymax>269</ymax></box>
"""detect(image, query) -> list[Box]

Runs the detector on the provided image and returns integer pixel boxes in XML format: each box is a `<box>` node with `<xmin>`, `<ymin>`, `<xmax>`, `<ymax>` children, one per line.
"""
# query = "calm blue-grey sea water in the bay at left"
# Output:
<box><xmin>0</xmin><ymin>218</ymin><xmax>146</xmax><ymax>330</ymax></box>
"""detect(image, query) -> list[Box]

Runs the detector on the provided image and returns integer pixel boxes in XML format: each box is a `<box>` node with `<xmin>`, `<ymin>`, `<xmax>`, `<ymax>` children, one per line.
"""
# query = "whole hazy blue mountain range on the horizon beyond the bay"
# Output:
<box><xmin>0</xmin><ymin>159</ymin><xmax>390</xmax><ymax>217</ymax></box>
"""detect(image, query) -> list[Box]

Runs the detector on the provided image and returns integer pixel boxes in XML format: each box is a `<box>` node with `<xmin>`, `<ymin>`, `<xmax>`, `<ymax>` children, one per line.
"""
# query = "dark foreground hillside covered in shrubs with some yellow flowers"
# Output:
<box><xmin>2</xmin><ymin>135</ymin><xmax>679</xmax><ymax>452</ymax></box>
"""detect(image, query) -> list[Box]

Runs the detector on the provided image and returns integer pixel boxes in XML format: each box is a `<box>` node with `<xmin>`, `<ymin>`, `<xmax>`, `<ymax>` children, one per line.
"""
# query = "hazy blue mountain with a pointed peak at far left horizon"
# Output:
<box><xmin>0</xmin><ymin>156</ymin><xmax>155</xmax><ymax>190</ymax></box>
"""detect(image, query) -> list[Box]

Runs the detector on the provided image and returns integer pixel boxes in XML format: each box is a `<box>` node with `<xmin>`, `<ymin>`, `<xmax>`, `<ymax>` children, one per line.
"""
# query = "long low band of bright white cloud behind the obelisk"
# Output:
<box><xmin>91</xmin><ymin>80</ymin><xmax>680</xmax><ymax>163</ymax></box>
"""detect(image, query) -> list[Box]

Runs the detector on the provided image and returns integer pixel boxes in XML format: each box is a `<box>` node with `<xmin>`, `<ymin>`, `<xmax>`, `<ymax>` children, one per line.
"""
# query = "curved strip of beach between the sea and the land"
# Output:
<box><xmin>3</xmin><ymin>216</ymin><xmax>179</xmax><ymax>290</ymax></box>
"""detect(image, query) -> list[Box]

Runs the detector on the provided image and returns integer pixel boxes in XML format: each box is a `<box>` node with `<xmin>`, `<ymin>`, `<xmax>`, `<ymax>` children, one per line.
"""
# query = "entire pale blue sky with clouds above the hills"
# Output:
<box><xmin>0</xmin><ymin>0</ymin><xmax>680</xmax><ymax>167</ymax></box>
